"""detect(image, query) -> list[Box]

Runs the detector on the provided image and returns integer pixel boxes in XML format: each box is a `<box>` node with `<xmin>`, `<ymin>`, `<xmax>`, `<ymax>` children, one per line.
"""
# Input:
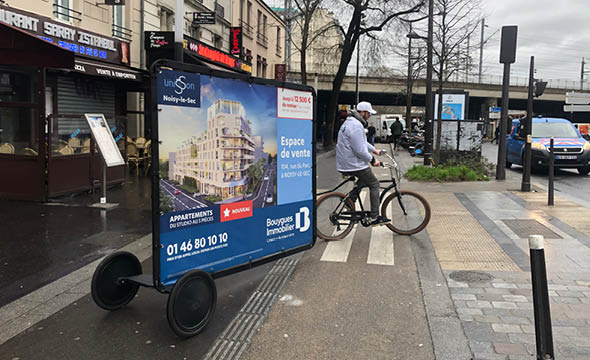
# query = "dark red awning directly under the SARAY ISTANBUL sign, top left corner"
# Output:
<box><xmin>0</xmin><ymin>22</ymin><xmax>74</xmax><ymax>69</ymax></box>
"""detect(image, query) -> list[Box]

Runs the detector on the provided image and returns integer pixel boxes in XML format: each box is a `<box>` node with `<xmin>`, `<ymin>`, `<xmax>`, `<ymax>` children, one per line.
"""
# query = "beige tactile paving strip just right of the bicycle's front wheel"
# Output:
<box><xmin>422</xmin><ymin>193</ymin><xmax>520</xmax><ymax>271</ymax></box>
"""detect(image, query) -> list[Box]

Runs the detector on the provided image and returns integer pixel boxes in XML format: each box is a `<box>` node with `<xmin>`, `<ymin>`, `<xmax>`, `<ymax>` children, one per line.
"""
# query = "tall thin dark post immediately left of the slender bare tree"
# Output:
<box><xmin>424</xmin><ymin>0</ymin><xmax>434</xmax><ymax>165</ymax></box>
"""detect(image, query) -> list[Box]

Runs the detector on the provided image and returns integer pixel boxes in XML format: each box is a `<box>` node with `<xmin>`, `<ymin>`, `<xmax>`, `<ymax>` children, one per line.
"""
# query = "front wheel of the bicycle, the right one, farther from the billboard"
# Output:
<box><xmin>381</xmin><ymin>190</ymin><xmax>430</xmax><ymax>235</ymax></box>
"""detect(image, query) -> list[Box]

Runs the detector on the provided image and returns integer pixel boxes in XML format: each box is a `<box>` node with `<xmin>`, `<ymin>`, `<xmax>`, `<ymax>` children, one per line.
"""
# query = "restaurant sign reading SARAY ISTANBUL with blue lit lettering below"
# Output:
<box><xmin>0</xmin><ymin>5</ymin><xmax>130</xmax><ymax>65</ymax></box>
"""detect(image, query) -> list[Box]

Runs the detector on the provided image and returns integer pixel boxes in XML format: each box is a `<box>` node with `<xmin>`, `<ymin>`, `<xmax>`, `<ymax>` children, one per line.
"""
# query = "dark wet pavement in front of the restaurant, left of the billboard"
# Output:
<box><xmin>0</xmin><ymin>177</ymin><xmax>152</xmax><ymax>306</ymax></box>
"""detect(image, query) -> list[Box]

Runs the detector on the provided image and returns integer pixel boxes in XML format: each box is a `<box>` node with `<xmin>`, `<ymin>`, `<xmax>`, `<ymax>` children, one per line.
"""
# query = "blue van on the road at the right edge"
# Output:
<box><xmin>506</xmin><ymin>117</ymin><xmax>590</xmax><ymax>175</ymax></box>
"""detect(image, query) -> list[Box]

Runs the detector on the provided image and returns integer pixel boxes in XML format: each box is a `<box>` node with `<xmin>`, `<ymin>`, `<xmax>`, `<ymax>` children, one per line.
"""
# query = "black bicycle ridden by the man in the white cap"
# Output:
<box><xmin>316</xmin><ymin>152</ymin><xmax>431</xmax><ymax>241</ymax></box>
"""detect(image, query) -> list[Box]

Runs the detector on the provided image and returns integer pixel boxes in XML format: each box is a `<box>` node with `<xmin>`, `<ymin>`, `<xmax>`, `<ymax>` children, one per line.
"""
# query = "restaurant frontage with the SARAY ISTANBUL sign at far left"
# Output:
<box><xmin>0</xmin><ymin>0</ymin><xmax>149</xmax><ymax>200</ymax></box>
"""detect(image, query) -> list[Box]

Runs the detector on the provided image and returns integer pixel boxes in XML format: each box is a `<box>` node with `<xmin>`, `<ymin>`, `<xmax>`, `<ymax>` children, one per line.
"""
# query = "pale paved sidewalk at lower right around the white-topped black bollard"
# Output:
<box><xmin>427</xmin><ymin>190</ymin><xmax>590</xmax><ymax>360</ymax></box>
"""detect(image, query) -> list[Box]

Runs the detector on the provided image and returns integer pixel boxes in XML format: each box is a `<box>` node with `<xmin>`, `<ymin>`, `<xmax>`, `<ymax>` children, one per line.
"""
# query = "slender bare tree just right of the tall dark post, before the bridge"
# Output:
<box><xmin>433</xmin><ymin>0</ymin><xmax>481</xmax><ymax>163</ymax></box>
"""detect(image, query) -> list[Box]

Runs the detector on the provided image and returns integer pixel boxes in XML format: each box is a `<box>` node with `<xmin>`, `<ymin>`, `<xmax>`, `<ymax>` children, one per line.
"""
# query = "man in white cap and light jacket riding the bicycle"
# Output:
<box><xmin>336</xmin><ymin>101</ymin><xmax>390</xmax><ymax>226</ymax></box>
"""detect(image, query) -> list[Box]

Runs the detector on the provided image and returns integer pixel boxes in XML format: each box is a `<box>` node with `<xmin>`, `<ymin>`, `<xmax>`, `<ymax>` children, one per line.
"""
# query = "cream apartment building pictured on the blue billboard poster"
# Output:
<box><xmin>170</xmin><ymin>100</ymin><xmax>262</xmax><ymax>200</ymax></box>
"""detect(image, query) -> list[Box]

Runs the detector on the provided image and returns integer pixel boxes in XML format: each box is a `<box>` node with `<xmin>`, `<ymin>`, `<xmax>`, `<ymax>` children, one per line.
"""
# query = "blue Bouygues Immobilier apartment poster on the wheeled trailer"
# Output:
<box><xmin>157</xmin><ymin>66</ymin><xmax>313</xmax><ymax>283</ymax></box>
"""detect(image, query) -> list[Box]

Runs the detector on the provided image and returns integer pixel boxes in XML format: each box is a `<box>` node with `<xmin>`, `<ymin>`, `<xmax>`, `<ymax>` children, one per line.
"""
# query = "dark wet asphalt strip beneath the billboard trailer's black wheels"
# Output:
<box><xmin>0</xmin><ymin>259</ymin><xmax>273</xmax><ymax>360</ymax></box>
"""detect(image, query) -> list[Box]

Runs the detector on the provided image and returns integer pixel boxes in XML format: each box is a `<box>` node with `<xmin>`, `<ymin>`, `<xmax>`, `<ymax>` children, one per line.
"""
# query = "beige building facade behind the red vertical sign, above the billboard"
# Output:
<box><xmin>232</xmin><ymin>0</ymin><xmax>286</xmax><ymax>79</ymax></box>
